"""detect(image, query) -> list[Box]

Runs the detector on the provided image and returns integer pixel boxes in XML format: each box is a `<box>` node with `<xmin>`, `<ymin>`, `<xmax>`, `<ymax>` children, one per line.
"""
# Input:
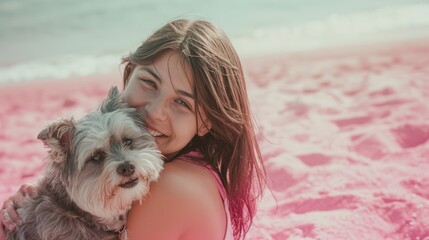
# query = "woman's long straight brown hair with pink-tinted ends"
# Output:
<box><xmin>123</xmin><ymin>19</ymin><xmax>265</xmax><ymax>239</ymax></box>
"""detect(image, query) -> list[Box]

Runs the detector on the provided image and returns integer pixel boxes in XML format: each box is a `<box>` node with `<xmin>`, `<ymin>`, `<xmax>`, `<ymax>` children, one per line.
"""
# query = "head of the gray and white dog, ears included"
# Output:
<box><xmin>38</xmin><ymin>88</ymin><xmax>163</xmax><ymax>219</ymax></box>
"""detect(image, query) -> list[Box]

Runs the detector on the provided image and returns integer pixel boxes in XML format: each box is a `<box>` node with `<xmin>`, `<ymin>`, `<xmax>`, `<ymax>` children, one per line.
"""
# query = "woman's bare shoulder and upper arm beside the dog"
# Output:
<box><xmin>127</xmin><ymin>160</ymin><xmax>226</xmax><ymax>240</ymax></box>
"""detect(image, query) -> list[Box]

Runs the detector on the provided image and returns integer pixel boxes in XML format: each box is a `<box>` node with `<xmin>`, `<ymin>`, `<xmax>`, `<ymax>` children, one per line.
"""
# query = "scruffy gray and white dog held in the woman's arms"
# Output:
<box><xmin>7</xmin><ymin>87</ymin><xmax>163</xmax><ymax>240</ymax></box>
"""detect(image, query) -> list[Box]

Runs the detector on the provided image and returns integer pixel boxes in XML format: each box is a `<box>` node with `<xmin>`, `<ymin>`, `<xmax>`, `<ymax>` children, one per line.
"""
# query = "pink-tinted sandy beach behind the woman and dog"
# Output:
<box><xmin>0</xmin><ymin>41</ymin><xmax>429</xmax><ymax>240</ymax></box>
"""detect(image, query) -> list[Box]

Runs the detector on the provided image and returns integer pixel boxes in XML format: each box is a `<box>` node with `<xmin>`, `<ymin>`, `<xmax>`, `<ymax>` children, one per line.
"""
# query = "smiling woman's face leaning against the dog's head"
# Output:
<box><xmin>123</xmin><ymin>51</ymin><xmax>208</xmax><ymax>158</ymax></box>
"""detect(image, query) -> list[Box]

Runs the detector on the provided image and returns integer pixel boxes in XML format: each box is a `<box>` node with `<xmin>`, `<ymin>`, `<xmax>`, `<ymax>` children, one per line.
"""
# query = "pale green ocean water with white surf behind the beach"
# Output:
<box><xmin>0</xmin><ymin>0</ymin><xmax>429</xmax><ymax>85</ymax></box>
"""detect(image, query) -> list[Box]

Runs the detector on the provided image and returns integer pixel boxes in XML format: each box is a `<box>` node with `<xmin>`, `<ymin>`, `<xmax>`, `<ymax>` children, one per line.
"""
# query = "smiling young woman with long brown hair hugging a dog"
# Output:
<box><xmin>0</xmin><ymin>19</ymin><xmax>265</xmax><ymax>240</ymax></box>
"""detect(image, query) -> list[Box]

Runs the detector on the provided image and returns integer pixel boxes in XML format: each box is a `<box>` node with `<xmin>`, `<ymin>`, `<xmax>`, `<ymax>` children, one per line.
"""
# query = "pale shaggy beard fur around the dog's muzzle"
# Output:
<box><xmin>67</xmin><ymin>149</ymin><xmax>161</xmax><ymax>219</ymax></box>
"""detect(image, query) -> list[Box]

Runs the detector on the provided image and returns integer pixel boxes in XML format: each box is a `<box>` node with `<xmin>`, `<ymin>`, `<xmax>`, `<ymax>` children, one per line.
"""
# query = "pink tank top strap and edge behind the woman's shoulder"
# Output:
<box><xmin>178</xmin><ymin>151</ymin><xmax>234</xmax><ymax>240</ymax></box>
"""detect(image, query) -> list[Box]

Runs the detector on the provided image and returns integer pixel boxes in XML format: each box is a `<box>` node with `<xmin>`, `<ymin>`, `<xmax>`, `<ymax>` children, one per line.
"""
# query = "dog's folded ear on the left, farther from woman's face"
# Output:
<box><xmin>37</xmin><ymin>118</ymin><xmax>75</xmax><ymax>162</ymax></box>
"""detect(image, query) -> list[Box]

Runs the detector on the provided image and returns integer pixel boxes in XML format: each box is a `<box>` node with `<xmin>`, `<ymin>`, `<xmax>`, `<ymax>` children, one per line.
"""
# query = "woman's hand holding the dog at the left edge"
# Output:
<box><xmin>0</xmin><ymin>184</ymin><xmax>37</xmax><ymax>234</ymax></box>
